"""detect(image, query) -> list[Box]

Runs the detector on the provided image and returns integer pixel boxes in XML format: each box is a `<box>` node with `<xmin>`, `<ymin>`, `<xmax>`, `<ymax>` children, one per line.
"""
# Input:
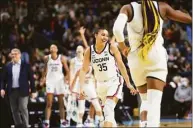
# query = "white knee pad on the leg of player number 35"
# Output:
<box><xmin>103</xmin><ymin>99</ymin><xmax>116</xmax><ymax>123</ymax></box>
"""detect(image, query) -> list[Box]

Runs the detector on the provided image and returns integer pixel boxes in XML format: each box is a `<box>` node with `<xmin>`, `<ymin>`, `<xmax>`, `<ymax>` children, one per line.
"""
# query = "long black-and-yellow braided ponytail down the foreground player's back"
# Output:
<box><xmin>139</xmin><ymin>0</ymin><xmax>160</xmax><ymax>60</ymax></box>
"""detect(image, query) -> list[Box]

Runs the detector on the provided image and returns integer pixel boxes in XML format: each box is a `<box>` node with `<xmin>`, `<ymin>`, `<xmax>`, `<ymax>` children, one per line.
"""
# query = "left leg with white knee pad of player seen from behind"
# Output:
<box><xmin>137</xmin><ymin>84</ymin><xmax>148</xmax><ymax>127</ymax></box>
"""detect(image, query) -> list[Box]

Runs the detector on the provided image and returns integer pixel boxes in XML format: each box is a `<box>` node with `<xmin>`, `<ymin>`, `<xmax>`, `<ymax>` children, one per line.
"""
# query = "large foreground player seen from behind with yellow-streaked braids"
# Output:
<box><xmin>113</xmin><ymin>0</ymin><xmax>192</xmax><ymax>127</ymax></box>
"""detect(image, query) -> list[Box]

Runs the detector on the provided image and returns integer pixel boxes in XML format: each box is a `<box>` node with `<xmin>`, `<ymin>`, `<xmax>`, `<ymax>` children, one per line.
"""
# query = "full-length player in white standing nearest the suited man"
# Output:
<box><xmin>42</xmin><ymin>44</ymin><xmax>69</xmax><ymax>128</ymax></box>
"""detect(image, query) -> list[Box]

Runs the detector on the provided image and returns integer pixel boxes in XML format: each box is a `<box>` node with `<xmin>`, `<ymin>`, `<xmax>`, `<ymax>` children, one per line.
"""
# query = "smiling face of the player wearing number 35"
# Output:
<box><xmin>96</xmin><ymin>29</ymin><xmax>109</xmax><ymax>43</ymax></box>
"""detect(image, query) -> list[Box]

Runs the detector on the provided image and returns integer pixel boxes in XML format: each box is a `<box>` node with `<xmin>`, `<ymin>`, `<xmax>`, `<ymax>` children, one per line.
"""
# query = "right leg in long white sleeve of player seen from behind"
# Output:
<box><xmin>147</xmin><ymin>77</ymin><xmax>166</xmax><ymax>127</ymax></box>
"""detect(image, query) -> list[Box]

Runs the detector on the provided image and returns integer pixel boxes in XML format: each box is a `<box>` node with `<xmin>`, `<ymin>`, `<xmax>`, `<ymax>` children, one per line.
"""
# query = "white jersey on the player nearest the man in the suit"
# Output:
<box><xmin>46</xmin><ymin>55</ymin><xmax>64</xmax><ymax>83</ymax></box>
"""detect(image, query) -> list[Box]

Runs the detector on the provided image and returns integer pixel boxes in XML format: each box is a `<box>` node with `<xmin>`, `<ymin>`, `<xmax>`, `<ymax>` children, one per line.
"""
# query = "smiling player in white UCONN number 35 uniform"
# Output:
<box><xmin>79</xmin><ymin>28</ymin><xmax>136</xmax><ymax>127</ymax></box>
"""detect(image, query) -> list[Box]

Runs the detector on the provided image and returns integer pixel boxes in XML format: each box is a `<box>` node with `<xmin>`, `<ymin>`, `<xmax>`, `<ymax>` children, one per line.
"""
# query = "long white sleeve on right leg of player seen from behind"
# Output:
<box><xmin>147</xmin><ymin>89</ymin><xmax>163</xmax><ymax>127</ymax></box>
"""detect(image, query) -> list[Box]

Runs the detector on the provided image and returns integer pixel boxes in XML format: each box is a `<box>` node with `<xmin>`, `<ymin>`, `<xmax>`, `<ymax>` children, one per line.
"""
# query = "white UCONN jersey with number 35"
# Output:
<box><xmin>90</xmin><ymin>43</ymin><xmax>119</xmax><ymax>82</ymax></box>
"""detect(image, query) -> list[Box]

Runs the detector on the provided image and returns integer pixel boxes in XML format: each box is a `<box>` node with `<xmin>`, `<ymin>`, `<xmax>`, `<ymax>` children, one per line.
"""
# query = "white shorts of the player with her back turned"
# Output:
<box><xmin>127</xmin><ymin>45</ymin><xmax>168</xmax><ymax>86</ymax></box>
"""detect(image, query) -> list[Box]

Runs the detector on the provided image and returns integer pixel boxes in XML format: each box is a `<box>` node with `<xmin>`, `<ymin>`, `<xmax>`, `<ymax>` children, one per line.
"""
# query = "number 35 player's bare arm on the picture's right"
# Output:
<box><xmin>110</xmin><ymin>44</ymin><xmax>136</xmax><ymax>94</ymax></box>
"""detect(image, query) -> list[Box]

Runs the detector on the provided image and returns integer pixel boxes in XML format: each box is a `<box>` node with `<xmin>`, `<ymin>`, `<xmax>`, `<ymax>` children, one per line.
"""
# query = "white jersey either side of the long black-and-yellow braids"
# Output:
<box><xmin>127</xmin><ymin>1</ymin><xmax>164</xmax><ymax>52</ymax></box>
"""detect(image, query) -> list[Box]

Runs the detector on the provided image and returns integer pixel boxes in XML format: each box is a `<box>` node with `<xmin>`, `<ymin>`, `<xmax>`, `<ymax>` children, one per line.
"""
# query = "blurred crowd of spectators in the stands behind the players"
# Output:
<box><xmin>0</xmin><ymin>0</ymin><xmax>192</xmax><ymax>124</ymax></box>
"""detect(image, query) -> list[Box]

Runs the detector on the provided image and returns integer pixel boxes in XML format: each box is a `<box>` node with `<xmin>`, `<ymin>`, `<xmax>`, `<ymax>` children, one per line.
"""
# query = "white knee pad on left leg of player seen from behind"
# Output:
<box><xmin>139</xmin><ymin>93</ymin><xmax>148</xmax><ymax>113</ymax></box>
